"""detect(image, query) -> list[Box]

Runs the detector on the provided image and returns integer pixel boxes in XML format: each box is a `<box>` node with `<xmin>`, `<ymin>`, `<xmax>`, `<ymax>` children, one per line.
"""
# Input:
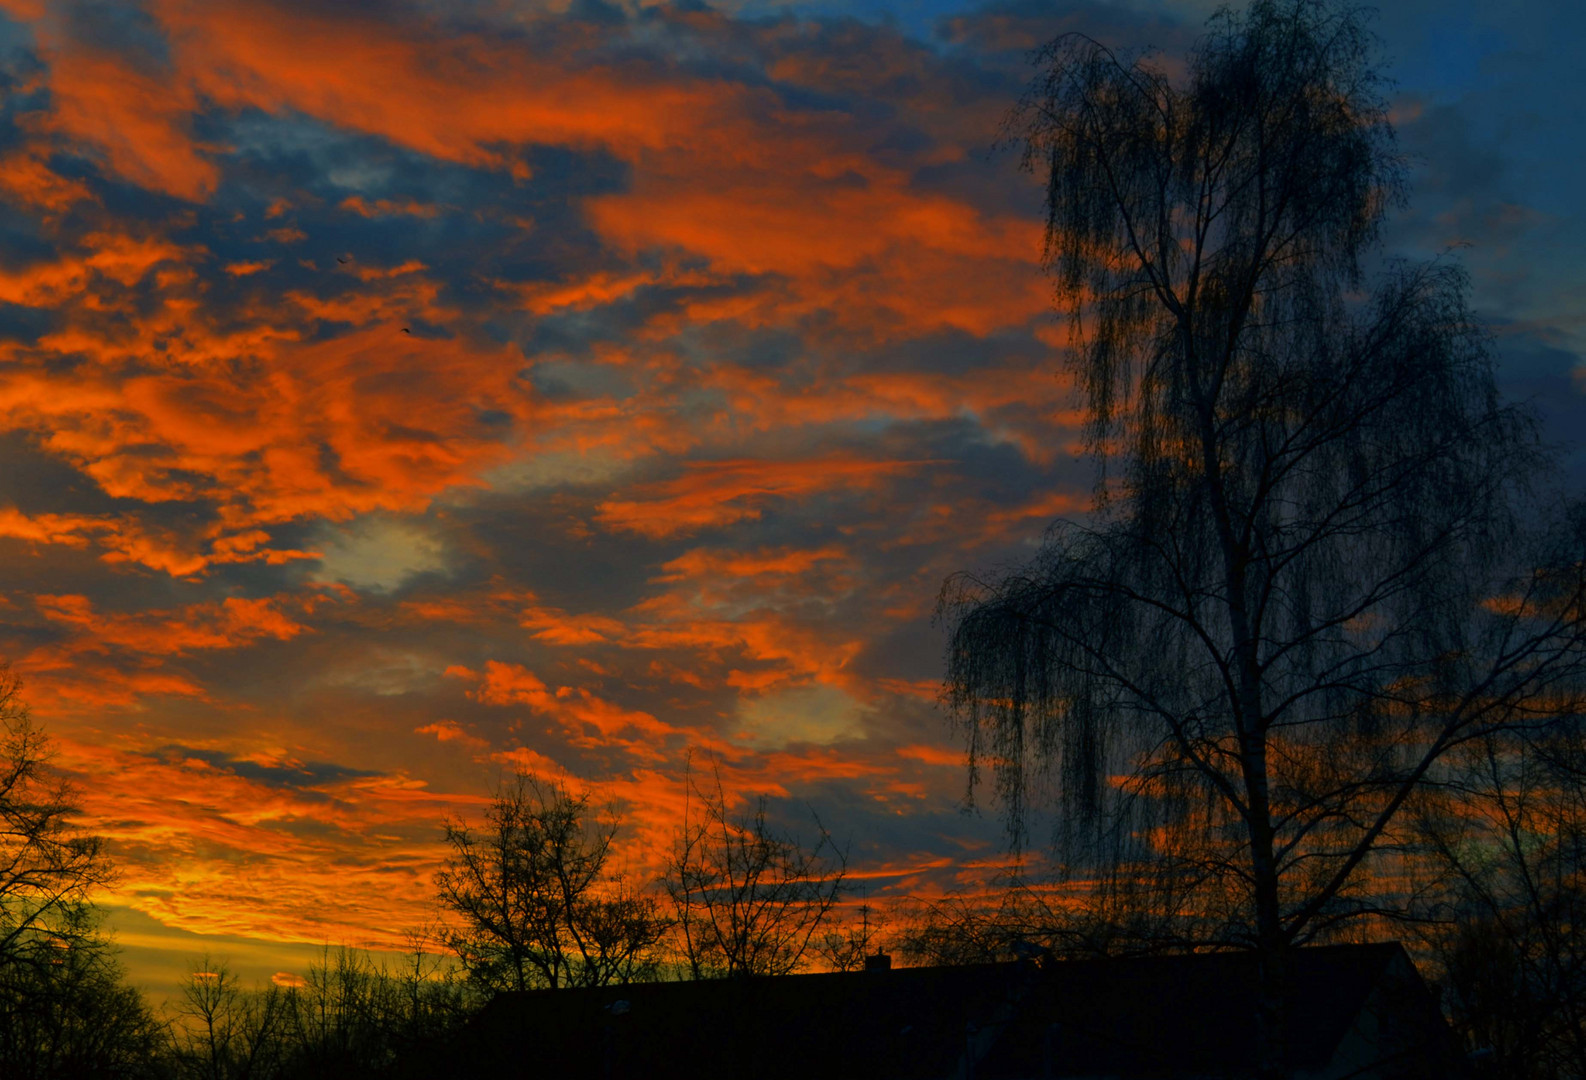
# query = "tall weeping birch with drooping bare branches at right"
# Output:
<box><xmin>942</xmin><ymin>0</ymin><xmax>1583</xmax><ymax>1077</ymax></box>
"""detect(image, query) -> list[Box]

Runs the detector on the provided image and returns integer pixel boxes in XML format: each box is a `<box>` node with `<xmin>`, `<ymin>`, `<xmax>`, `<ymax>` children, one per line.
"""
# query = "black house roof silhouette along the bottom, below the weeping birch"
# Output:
<box><xmin>428</xmin><ymin>944</ymin><xmax>1464</xmax><ymax>1080</ymax></box>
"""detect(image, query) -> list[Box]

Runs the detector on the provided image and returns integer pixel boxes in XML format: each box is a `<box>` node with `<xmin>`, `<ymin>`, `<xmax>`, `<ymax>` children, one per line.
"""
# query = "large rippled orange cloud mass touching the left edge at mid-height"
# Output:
<box><xmin>0</xmin><ymin>314</ymin><xmax>528</xmax><ymax>539</ymax></box>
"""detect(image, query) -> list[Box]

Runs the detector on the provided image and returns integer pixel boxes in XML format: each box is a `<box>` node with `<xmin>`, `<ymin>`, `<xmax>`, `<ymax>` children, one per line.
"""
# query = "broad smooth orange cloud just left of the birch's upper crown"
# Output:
<box><xmin>590</xmin><ymin>160</ymin><xmax>1050</xmax><ymax>336</ymax></box>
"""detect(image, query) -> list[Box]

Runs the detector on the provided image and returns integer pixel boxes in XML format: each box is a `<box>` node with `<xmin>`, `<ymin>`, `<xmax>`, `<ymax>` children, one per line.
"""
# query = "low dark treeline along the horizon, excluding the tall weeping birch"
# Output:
<box><xmin>9</xmin><ymin>662</ymin><xmax>1586</xmax><ymax>1080</ymax></box>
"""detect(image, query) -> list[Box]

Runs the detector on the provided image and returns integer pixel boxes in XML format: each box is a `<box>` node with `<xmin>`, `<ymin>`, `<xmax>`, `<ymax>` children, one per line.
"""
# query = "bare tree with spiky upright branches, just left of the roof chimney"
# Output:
<box><xmin>663</xmin><ymin>761</ymin><xmax>847</xmax><ymax>979</ymax></box>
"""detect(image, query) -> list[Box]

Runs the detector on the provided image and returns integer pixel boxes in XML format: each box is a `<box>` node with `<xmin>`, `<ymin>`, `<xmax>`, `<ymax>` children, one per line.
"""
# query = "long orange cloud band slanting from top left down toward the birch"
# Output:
<box><xmin>12</xmin><ymin>0</ymin><xmax>1048</xmax><ymax>335</ymax></box>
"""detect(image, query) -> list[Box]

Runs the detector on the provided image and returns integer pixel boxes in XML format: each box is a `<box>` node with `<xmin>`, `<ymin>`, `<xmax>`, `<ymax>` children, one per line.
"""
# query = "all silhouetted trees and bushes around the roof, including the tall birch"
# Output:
<box><xmin>0</xmin><ymin>0</ymin><xmax>1586</xmax><ymax>1080</ymax></box>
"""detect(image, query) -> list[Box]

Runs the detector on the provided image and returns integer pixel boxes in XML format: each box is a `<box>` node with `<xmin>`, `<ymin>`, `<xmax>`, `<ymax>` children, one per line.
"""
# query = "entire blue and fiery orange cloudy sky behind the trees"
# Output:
<box><xmin>0</xmin><ymin>0</ymin><xmax>1586</xmax><ymax>994</ymax></box>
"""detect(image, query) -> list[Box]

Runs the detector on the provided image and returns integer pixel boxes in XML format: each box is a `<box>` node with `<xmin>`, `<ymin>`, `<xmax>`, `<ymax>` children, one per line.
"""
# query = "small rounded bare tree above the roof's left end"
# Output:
<box><xmin>436</xmin><ymin>776</ymin><xmax>666</xmax><ymax>990</ymax></box>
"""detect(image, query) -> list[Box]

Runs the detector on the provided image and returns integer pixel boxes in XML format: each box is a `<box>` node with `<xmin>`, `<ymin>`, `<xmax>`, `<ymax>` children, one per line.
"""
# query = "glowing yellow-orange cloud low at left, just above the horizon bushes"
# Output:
<box><xmin>57</xmin><ymin>739</ymin><xmax>485</xmax><ymax>947</ymax></box>
